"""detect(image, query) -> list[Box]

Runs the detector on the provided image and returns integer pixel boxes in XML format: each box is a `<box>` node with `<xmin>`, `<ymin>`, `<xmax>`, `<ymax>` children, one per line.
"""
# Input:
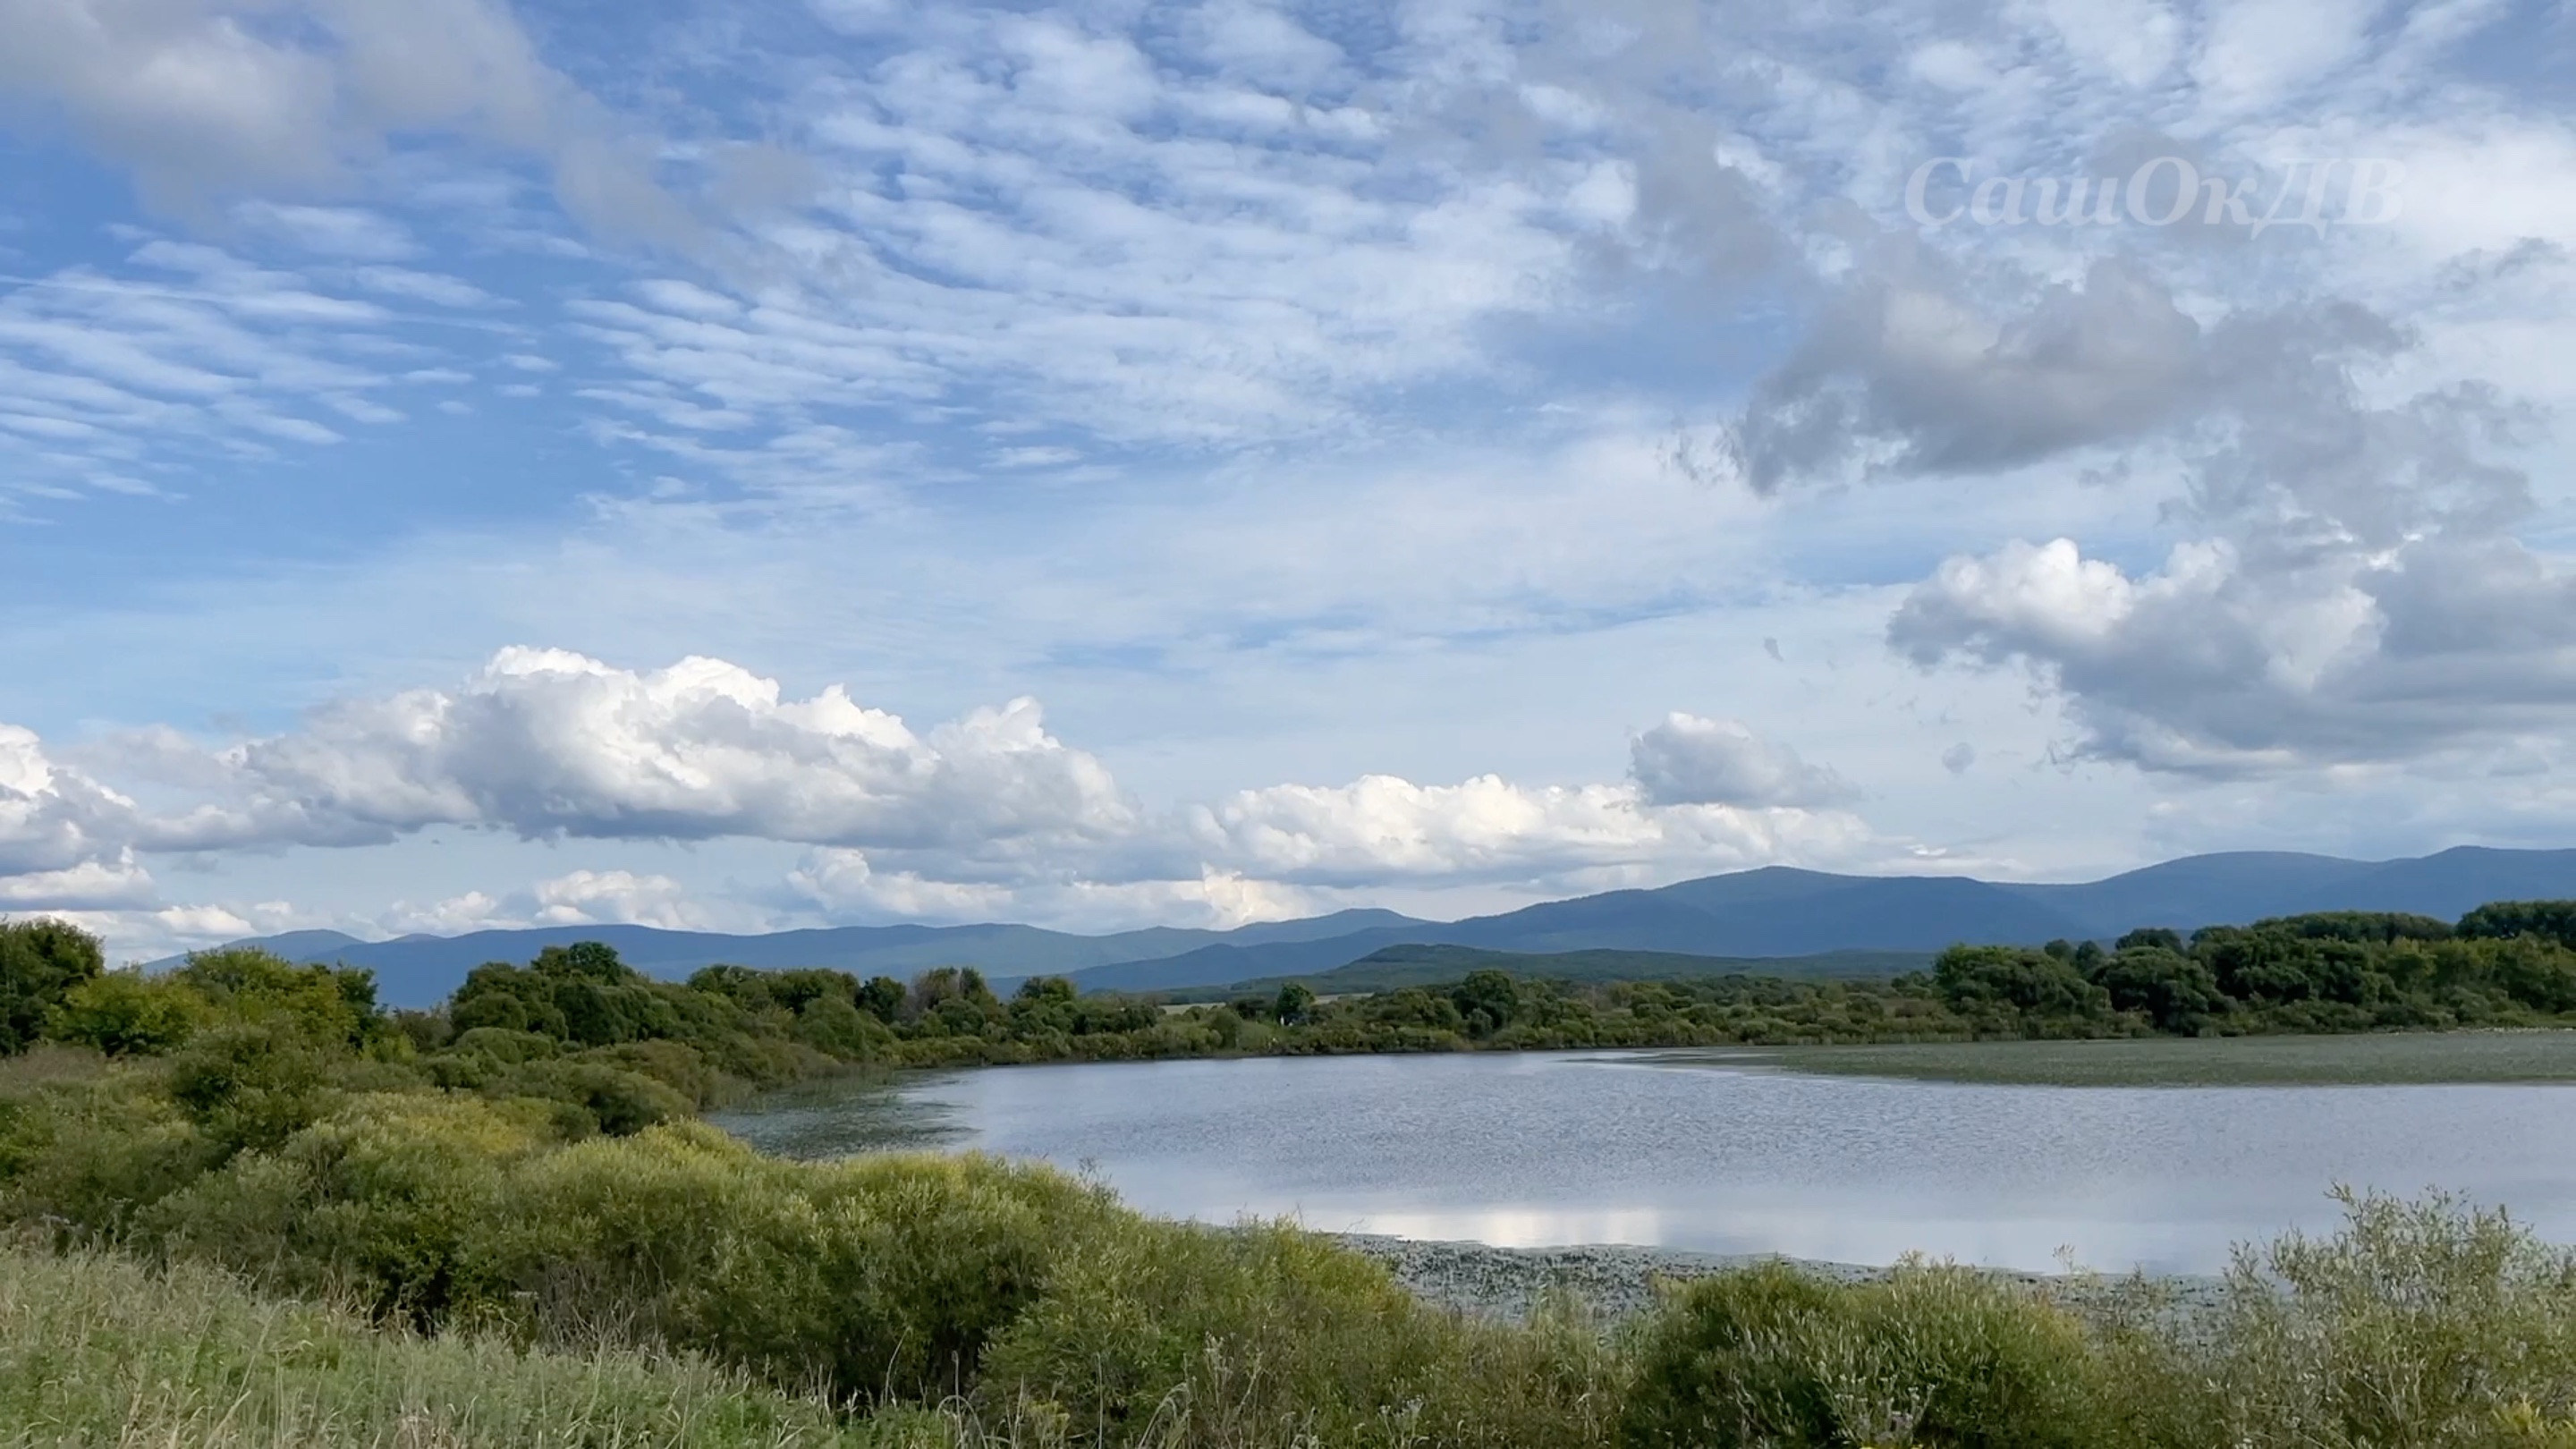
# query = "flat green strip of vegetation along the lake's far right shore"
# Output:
<box><xmin>1654</xmin><ymin>1031</ymin><xmax>2576</xmax><ymax>1088</ymax></box>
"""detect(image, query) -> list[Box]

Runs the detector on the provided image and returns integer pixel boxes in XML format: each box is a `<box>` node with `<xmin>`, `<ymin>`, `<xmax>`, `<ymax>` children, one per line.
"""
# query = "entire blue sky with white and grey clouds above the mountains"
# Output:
<box><xmin>0</xmin><ymin>0</ymin><xmax>2576</xmax><ymax>959</ymax></box>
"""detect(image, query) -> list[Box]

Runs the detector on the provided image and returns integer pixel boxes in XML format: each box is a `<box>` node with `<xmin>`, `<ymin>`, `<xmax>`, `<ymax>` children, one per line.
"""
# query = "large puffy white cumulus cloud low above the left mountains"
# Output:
<box><xmin>144</xmin><ymin>648</ymin><xmax>1133</xmax><ymax>851</ymax></box>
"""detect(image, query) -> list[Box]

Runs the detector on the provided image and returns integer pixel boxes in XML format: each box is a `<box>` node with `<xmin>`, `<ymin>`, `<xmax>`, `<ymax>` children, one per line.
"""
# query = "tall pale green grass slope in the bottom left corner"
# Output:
<box><xmin>0</xmin><ymin>1227</ymin><xmax>945</xmax><ymax>1449</ymax></box>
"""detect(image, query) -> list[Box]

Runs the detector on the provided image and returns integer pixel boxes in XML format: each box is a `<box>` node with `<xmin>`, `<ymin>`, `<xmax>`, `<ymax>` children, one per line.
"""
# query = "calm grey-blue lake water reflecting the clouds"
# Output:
<box><xmin>724</xmin><ymin>1052</ymin><xmax>2576</xmax><ymax>1271</ymax></box>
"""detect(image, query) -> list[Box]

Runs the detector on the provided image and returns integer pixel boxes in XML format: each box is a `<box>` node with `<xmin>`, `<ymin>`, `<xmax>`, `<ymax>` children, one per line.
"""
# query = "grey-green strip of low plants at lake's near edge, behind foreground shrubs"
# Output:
<box><xmin>1321</xmin><ymin>1233</ymin><xmax>2228</xmax><ymax>1323</ymax></box>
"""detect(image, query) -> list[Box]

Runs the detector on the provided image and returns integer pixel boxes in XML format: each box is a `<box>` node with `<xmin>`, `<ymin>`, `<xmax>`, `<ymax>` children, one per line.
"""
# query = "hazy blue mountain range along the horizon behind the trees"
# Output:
<box><xmin>176</xmin><ymin>845</ymin><xmax>2576</xmax><ymax>1005</ymax></box>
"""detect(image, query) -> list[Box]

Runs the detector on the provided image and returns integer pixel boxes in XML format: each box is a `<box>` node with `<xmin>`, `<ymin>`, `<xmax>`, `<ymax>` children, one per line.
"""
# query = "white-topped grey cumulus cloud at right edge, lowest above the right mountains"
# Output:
<box><xmin>1888</xmin><ymin>538</ymin><xmax>2576</xmax><ymax>776</ymax></box>
